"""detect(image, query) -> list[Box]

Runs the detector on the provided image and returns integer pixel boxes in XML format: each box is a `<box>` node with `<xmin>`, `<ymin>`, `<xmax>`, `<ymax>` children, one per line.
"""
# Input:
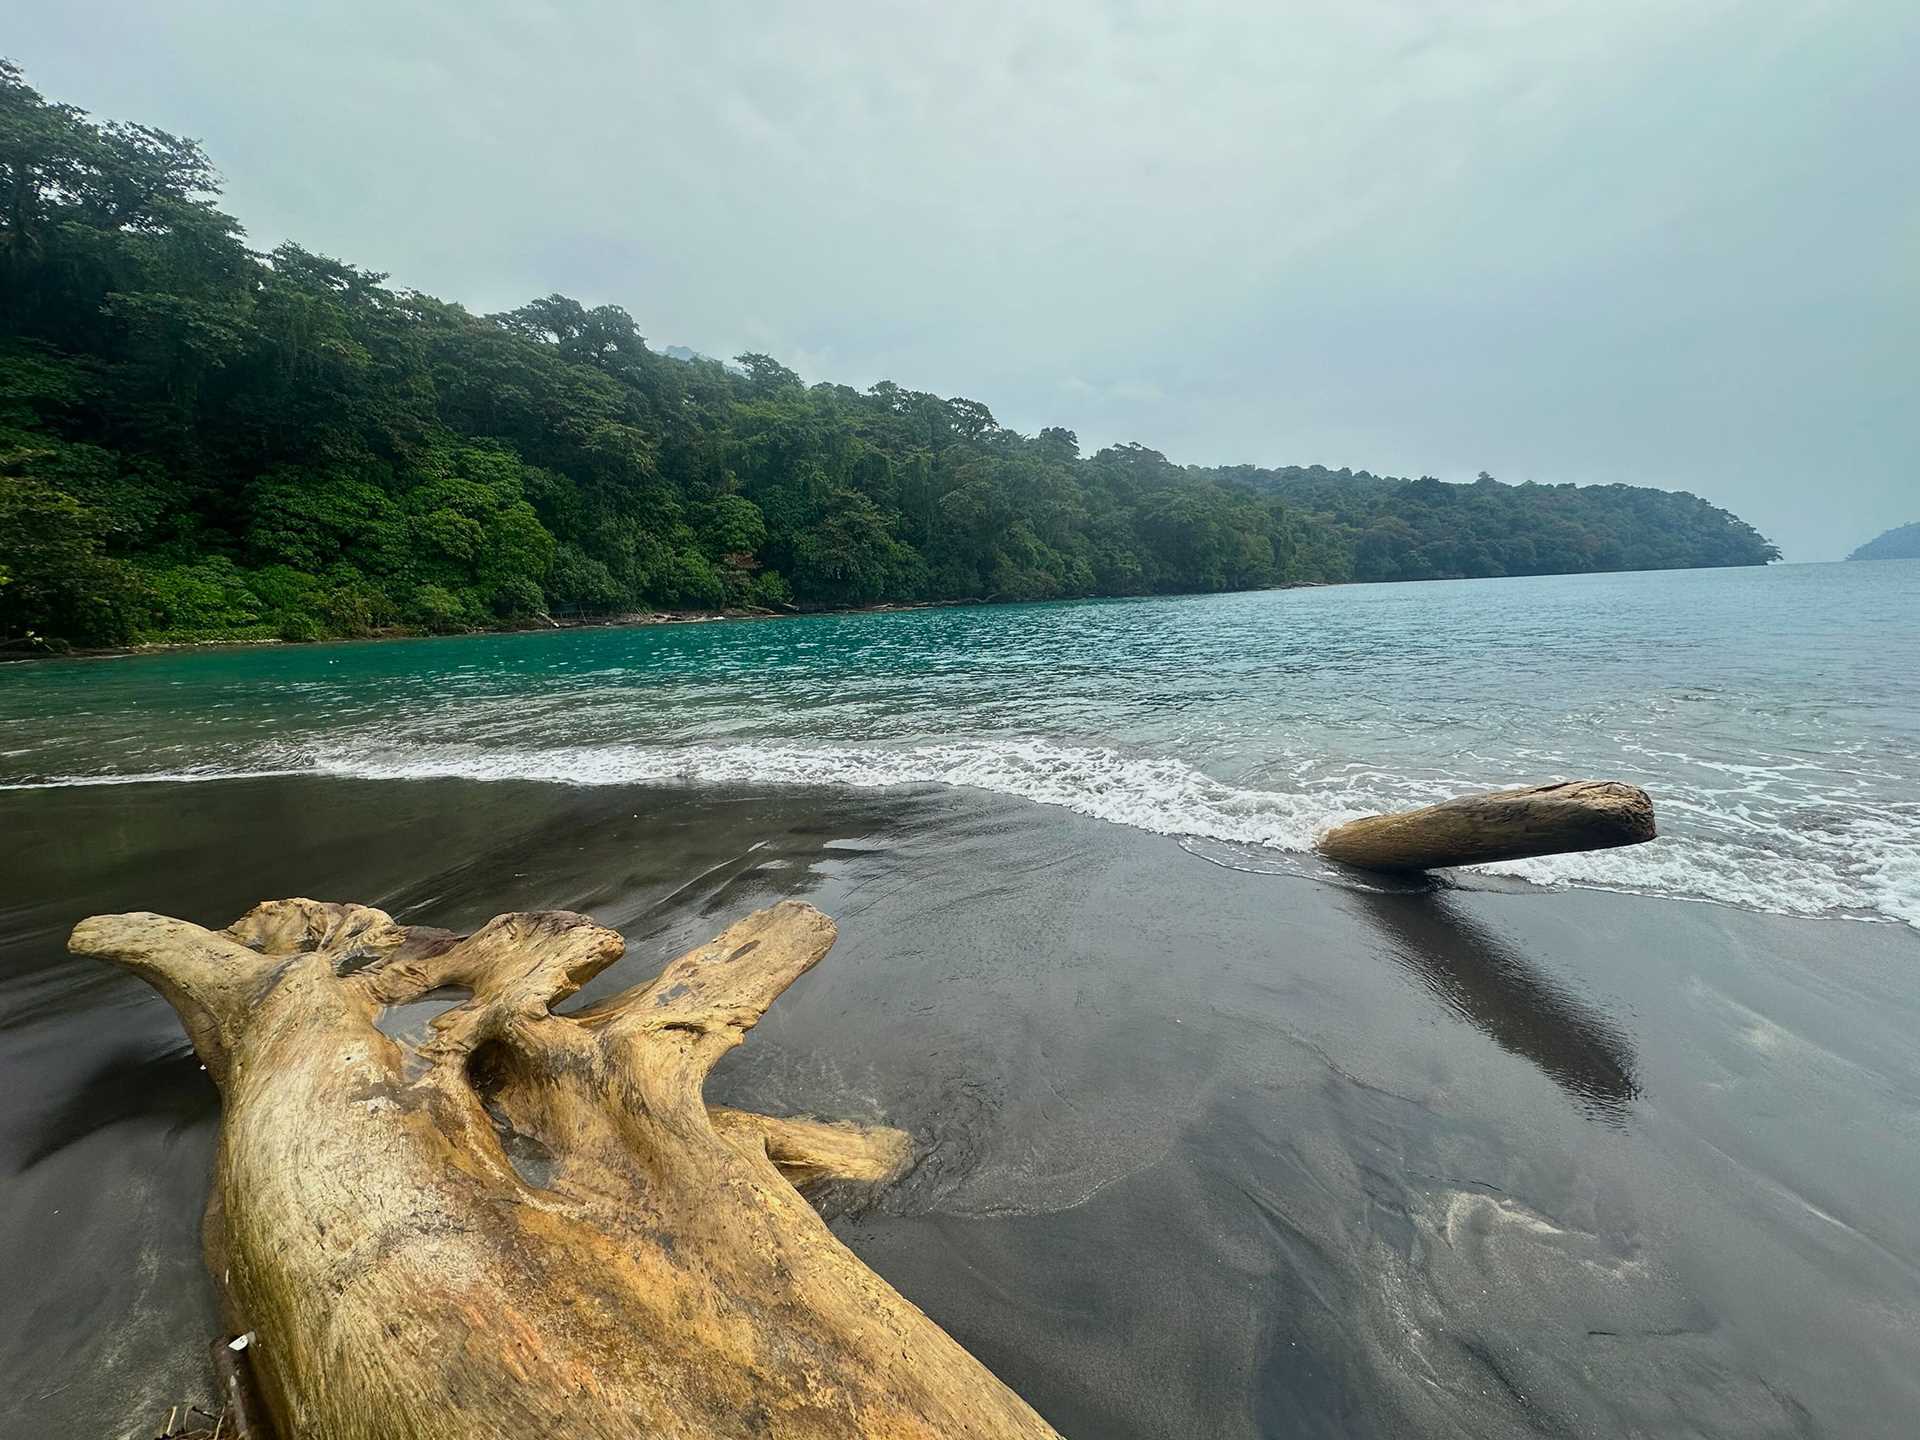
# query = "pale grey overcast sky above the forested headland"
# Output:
<box><xmin>0</xmin><ymin>0</ymin><xmax>1920</xmax><ymax>561</ymax></box>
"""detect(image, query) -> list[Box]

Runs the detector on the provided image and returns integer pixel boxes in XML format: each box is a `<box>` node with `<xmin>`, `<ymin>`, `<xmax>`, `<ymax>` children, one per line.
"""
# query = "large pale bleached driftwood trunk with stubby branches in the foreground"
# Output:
<box><xmin>71</xmin><ymin>900</ymin><xmax>1058</xmax><ymax>1440</ymax></box>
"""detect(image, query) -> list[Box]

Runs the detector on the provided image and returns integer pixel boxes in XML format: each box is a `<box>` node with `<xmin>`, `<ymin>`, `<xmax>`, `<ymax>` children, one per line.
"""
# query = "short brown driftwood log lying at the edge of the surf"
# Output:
<box><xmin>1313</xmin><ymin>780</ymin><xmax>1653</xmax><ymax>870</ymax></box>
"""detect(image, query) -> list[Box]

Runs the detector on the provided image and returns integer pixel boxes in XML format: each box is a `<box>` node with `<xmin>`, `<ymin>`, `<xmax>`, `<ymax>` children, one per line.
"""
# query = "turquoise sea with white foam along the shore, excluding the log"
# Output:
<box><xmin>0</xmin><ymin>561</ymin><xmax>1920</xmax><ymax>925</ymax></box>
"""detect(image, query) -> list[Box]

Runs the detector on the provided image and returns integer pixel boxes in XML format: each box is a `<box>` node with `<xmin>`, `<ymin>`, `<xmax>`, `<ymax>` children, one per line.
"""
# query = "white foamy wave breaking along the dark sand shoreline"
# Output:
<box><xmin>15</xmin><ymin>739</ymin><xmax>1920</xmax><ymax>927</ymax></box>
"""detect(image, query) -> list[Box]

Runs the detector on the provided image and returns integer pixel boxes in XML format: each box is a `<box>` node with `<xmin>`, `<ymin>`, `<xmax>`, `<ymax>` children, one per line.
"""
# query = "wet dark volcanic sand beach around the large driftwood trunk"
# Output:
<box><xmin>0</xmin><ymin>780</ymin><xmax>1920</xmax><ymax>1440</ymax></box>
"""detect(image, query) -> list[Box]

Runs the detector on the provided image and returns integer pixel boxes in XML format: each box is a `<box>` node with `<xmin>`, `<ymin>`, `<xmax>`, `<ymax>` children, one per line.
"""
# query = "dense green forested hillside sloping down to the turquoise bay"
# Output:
<box><xmin>0</xmin><ymin>67</ymin><xmax>1774</xmax><ymax>643</ymax></box>
